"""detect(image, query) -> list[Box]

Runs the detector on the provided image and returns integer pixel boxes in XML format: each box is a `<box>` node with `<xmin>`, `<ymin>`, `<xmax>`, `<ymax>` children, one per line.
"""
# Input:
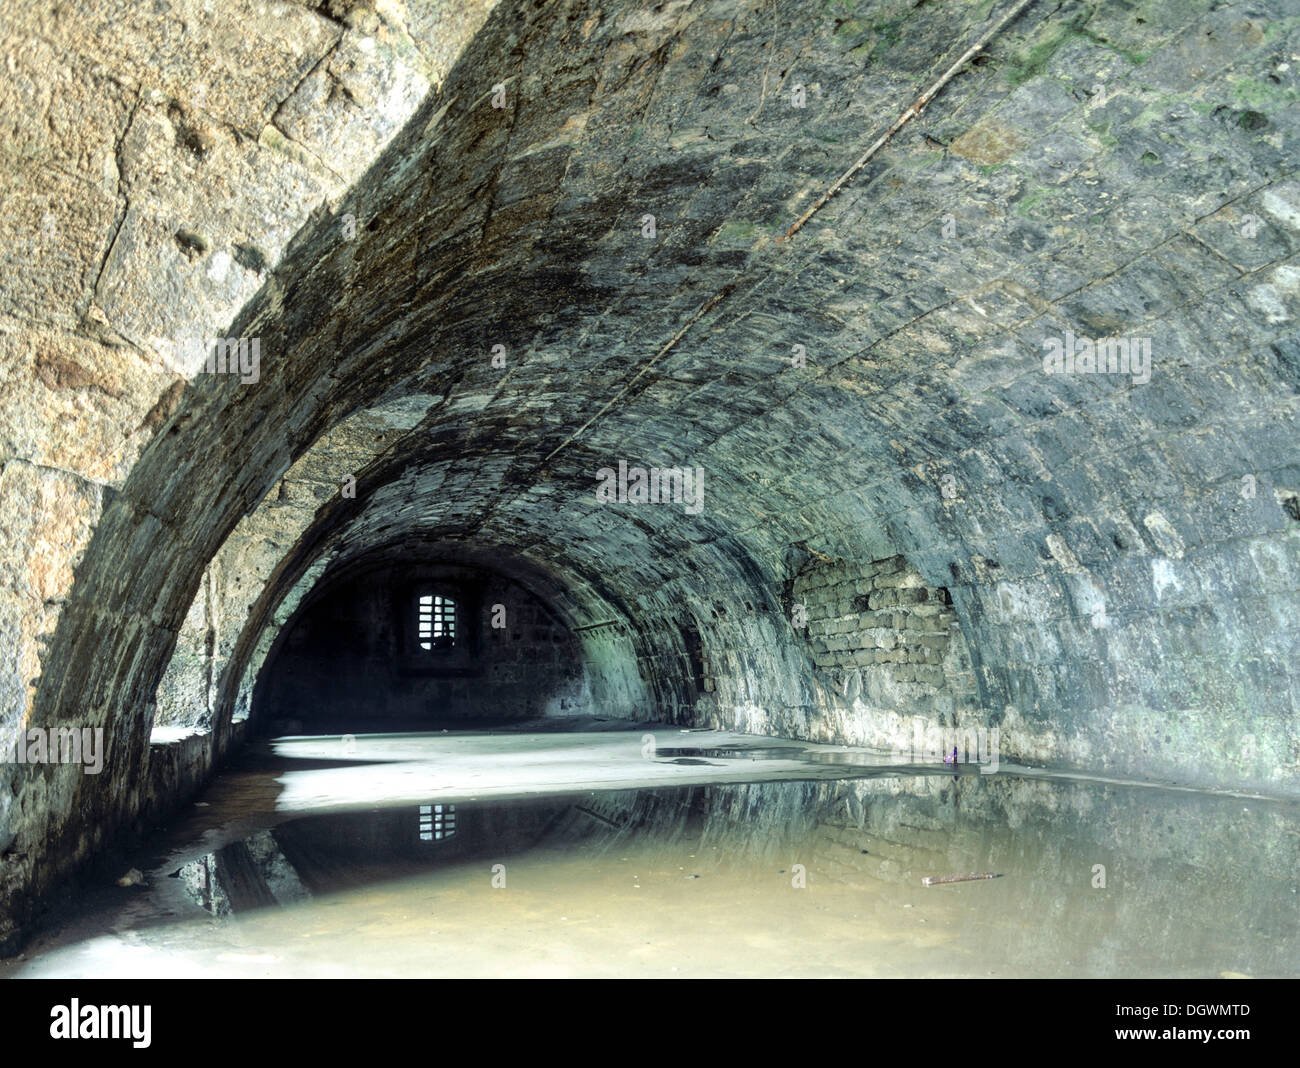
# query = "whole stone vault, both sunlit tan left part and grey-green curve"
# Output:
<box><xmin>0</xmin><ymin>0</ymin><xmax>1300</xmax><ymax>951</ymax></box>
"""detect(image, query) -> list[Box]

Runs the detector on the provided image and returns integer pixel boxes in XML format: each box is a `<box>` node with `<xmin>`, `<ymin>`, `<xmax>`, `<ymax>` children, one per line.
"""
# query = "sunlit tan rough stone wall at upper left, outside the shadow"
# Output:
<box><xmin>0</xmin><ymin>3</ymin><xmax>501</xmax><ymax>941</ymax></box>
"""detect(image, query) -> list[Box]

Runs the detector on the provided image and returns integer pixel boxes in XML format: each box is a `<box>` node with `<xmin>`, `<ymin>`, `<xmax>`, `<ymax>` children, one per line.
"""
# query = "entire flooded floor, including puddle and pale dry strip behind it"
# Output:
<box><xmin>0</xmin><ymin>724</ymin><xmax>1300</xmax><ymax>978</ymax></box>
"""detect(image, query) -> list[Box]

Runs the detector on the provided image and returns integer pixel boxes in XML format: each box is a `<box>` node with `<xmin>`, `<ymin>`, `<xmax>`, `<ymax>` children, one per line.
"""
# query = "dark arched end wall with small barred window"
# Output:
<box><xmin>254</xmin><ymin>561</ymin><xmax>593</xmax><ymax>733</ymax></box>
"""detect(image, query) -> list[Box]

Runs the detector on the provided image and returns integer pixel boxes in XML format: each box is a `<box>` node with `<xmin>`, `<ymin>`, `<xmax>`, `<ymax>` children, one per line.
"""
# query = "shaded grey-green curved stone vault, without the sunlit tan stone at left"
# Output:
<box><xmin>2</xmin><ymin>0</ymin><xmax>1300</xmax><ymax>951</ymax></box>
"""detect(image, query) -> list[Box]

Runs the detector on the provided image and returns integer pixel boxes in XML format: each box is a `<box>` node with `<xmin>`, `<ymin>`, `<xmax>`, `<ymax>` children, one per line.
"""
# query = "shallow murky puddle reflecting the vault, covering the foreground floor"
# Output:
<box><xmin>162</xmin><ymin>774</ymin><xmax>1300</xmax><ymax>977</ymax></box>
